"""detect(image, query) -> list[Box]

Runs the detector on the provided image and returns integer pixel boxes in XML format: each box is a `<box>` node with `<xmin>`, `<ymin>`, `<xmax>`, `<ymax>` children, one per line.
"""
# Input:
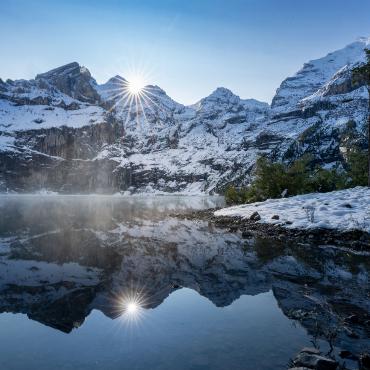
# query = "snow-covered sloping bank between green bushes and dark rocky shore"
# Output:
<box><xmin>215</xmin><ymin>187</ymin><xmax>370</xmax><ymax>233</ymax></box>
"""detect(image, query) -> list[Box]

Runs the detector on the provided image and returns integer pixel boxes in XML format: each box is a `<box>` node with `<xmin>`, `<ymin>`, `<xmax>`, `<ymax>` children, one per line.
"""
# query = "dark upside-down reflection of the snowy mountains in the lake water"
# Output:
<box><xmin>0</xmin><ymin>196</ymin><xmax>370</xmax><ymax>353</ymax></box>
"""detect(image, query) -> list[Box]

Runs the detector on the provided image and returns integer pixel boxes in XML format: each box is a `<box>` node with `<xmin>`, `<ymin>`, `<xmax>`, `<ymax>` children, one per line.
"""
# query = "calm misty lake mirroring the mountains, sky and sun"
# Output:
<box><xmin>0</xmin><ymin>195</ymin><xmax>369</xmax><ymax>370</ymax></box>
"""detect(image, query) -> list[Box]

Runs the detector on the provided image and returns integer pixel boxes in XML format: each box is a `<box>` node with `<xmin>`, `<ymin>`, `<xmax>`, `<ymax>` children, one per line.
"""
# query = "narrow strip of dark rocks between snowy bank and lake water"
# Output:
<box><xmin>174</xmin><ymin>208</ymin><xmax>370</xmax><ymax>253</ymax></box>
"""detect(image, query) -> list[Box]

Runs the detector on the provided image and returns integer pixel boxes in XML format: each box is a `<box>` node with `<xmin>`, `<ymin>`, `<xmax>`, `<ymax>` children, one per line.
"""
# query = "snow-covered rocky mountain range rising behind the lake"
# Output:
<box><xmin>0</xmin><ymin>38</ymin><xmax>370</xmax><ymax>193</ymax></box>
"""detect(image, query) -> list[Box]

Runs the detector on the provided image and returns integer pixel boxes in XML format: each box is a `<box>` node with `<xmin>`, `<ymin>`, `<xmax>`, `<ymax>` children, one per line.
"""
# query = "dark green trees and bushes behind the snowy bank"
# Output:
<box><xmin>225</xmin><ymin>149</ymin><xmax>368</xmax><ymax>204</ymax></box>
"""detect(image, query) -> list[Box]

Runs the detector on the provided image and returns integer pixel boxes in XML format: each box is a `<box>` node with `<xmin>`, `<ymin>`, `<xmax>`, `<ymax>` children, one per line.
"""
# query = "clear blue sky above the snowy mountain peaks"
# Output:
<box><xmin>0</xmin><ymin>0</ymin><xmax>370</xmax><ymax>104</ymax></box>
